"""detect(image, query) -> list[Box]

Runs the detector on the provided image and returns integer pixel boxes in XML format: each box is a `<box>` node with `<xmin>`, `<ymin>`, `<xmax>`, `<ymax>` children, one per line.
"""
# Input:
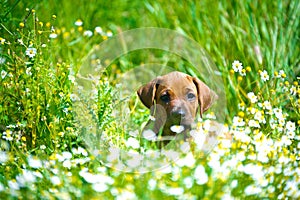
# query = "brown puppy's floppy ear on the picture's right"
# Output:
<box><xmin>193</xmin><ymin>77</ymin><xmax>218</xmax><ymax>117</ymax></box>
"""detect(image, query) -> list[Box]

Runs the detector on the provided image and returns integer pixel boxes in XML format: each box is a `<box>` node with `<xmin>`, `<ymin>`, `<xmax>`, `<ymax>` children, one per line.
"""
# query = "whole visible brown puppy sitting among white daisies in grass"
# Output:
<box><xmin>137</xmin><ymin>71</ymin><xmax>216</xmax><ymax>139</ymax></box>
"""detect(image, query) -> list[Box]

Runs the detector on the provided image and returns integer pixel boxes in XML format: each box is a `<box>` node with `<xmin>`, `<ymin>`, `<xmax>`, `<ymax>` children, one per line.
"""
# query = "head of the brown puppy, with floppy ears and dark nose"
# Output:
<box><xmin>137</xmin><ymin>72</ymin><xmax>216</xmax><ymax>124</ymax></box>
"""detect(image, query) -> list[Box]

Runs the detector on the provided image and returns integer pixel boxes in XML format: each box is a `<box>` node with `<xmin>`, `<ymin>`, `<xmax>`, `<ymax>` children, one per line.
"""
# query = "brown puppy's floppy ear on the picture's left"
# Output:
<box><xmin>137</xmin><ymin>78</ymin><xmax>158</xmax><ymax>109</ymax></box>
